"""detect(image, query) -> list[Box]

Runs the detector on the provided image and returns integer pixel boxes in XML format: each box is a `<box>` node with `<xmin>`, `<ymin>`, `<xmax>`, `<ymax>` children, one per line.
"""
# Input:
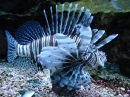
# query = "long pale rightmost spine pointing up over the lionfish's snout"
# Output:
<box><xmin>96</xmin><ymin>34</ymin><xmax>118</xmax><ymax>49</ymax></box>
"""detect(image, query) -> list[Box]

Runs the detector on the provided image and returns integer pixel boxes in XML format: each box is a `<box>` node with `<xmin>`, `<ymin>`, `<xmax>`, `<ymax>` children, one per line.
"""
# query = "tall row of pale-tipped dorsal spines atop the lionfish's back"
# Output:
<box><xmin>43</xmin><ymin>3</ymin><xmax>92</xmax><ymax>36</ymax></box>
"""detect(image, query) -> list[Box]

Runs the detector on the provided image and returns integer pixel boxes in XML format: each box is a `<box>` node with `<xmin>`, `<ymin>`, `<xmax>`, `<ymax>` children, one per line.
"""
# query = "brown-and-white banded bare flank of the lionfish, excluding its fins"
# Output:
<box><xmin>16</xmin><ymin>36</ymin><xmax>80</xmax><ymax>62</ymax></box>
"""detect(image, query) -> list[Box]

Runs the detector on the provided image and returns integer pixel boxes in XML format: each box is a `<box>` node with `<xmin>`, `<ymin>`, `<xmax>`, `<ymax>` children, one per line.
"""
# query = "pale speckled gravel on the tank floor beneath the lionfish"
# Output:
<box><xmin>0</xmin><ymin>59</ymin><xmax>130</xmax><ymax>97</ymax></box>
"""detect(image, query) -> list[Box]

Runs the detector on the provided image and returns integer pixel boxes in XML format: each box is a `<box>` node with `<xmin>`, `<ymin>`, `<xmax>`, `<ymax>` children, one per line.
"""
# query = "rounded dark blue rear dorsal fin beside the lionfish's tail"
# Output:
<box><xmin>15</xmin><ymin>21</ymin><xmax>46</xmax><ymax>45</ymax></box>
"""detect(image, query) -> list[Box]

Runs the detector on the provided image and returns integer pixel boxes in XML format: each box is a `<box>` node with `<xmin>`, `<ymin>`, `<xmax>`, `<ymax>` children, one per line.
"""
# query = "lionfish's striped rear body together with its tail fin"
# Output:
<box><xmin>6</xmin><ymin>26</ymin><xmax>57</xmax><ymax>62</ymax></box>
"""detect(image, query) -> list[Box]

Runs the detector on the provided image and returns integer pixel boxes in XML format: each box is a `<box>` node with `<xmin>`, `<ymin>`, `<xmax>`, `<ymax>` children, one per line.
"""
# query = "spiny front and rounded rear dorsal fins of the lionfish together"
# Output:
<box><xmin>15</xmin><ymin>3</ymin><xmax>92</xmax><ymax>45</ymax></box>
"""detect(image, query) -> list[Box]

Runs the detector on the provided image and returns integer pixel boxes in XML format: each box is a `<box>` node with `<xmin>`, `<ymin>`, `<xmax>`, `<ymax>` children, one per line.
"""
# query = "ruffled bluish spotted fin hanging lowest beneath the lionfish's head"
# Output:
<box><xmin>53</xmin><ymin>64</ymin><xmax>91</xmax><ymax>91</ymax></box>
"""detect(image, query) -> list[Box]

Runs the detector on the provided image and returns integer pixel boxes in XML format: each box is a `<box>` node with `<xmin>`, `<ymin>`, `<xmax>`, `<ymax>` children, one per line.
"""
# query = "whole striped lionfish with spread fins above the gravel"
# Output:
<box><xmin>5</xmin><ymin>3</ymin><xmax>118</xmax><ymax>90</ymax></box>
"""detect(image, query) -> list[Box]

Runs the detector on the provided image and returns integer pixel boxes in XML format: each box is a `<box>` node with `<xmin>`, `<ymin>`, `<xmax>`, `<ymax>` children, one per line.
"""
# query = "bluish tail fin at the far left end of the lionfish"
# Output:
<box><xmin>5</xmin><ymin>30</ymin><xmax>18</xmax><ymax>62</ymax></box>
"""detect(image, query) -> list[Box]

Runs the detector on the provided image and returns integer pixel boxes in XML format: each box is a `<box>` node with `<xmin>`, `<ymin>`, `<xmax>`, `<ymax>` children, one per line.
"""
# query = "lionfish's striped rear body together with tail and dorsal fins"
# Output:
<box><xmin>6</xmin><ymin>4</ymin><xmax>90</xmax><ymax>62</ymax></box>
